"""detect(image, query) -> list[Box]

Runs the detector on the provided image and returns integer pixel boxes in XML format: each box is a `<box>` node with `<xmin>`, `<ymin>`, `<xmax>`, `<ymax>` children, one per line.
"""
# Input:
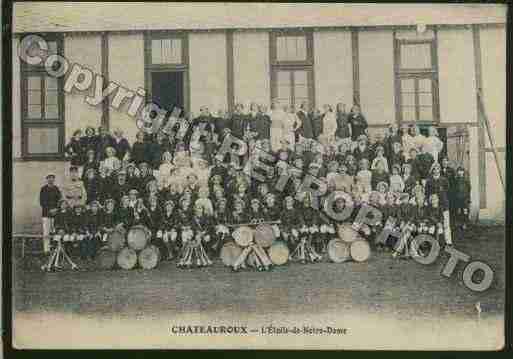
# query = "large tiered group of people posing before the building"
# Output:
<box><xmin>40</xmin><ymin>103</ymin><xmax>470</xmax><ymax>268</ymax></box>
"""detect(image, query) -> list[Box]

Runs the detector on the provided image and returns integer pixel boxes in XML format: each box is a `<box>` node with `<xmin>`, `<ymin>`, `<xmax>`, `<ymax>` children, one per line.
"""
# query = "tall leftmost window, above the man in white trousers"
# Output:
<box><xmin>21</xmin><ymin>37</ymin><xmax>64</xmax><ymax>159</ymax></box>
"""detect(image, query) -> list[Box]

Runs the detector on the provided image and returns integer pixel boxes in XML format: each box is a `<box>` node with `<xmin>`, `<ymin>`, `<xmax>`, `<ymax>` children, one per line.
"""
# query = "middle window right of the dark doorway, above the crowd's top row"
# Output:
<box><xmin>270</xmin><ymin>32</ymin><xmax>315</xmax><ymax>108</ymax></box>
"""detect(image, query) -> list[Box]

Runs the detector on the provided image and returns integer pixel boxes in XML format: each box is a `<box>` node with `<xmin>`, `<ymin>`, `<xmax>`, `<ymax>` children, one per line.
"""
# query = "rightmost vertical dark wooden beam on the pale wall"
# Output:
<box><xmin>472</xmin><ymin>24</ymin><xmax>486</xmax><ymax>208</ymax></box>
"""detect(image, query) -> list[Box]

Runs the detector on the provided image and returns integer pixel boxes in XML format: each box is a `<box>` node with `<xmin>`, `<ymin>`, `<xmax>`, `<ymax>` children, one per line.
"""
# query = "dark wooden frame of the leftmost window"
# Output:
<box><xmin>20</xmin><ymin>34</ymin><xmax>65</xmax><ymax>161</ymax></box>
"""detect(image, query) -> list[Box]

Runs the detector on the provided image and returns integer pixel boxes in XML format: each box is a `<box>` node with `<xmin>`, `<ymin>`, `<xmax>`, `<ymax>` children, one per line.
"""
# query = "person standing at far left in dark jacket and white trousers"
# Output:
<box><xmin>39</xmin><ymin>173</ymin><xmax>62</xmax><ymax>253</ymax></box>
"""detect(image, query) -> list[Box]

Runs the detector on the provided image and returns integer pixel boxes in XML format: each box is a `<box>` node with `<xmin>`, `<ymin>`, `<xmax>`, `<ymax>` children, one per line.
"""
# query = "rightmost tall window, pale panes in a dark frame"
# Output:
<box><xmin>395</xmin><ymin>32</ymin><xmax>439</xmax><ymax>123</ymax></box>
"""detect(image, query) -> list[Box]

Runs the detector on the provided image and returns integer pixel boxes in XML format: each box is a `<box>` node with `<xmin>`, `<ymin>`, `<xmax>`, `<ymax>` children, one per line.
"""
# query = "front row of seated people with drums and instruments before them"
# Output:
<box><xmin>47</xmin><ymin>183</ymin><xmax>444</xmax><ymax>271</ymax></box>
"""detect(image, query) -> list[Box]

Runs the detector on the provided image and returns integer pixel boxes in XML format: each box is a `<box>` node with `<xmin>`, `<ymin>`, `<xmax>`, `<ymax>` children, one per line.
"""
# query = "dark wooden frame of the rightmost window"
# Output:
<box><xmin>394</xmin><ymin>34</ymin><xmax>440</xmax><ymax>125</ymax></box>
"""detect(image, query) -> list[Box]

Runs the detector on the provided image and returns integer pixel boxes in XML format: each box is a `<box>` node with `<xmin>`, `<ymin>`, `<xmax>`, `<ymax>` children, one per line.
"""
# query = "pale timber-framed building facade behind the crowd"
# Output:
<box><xmin>12</xmin><ymin>3</ymin><xmax>506</xmax><ymax>231</ymax></box>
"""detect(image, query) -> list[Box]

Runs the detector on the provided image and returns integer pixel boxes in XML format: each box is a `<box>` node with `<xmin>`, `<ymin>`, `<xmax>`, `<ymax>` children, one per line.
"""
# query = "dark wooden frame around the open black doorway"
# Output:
<box><xmin>144</xmin><ymin>30</ymin><xmax>191</xmax><ymax>114</ymax></box>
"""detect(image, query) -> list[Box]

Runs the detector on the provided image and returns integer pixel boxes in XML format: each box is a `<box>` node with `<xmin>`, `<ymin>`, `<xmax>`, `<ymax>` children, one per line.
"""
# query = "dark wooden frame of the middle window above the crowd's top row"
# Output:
<box><xmin>269</xmin><ymin>29</ymin><xmax>315</xmax><ymax>110</ymax></box>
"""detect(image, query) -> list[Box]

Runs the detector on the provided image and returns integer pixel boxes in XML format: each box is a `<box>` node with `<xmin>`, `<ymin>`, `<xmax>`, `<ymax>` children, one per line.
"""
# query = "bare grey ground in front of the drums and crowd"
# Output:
<box><xmin>13</xmin><ymin>226</ymin><xmax>505</xmax><ymax>350</ymax></box>
